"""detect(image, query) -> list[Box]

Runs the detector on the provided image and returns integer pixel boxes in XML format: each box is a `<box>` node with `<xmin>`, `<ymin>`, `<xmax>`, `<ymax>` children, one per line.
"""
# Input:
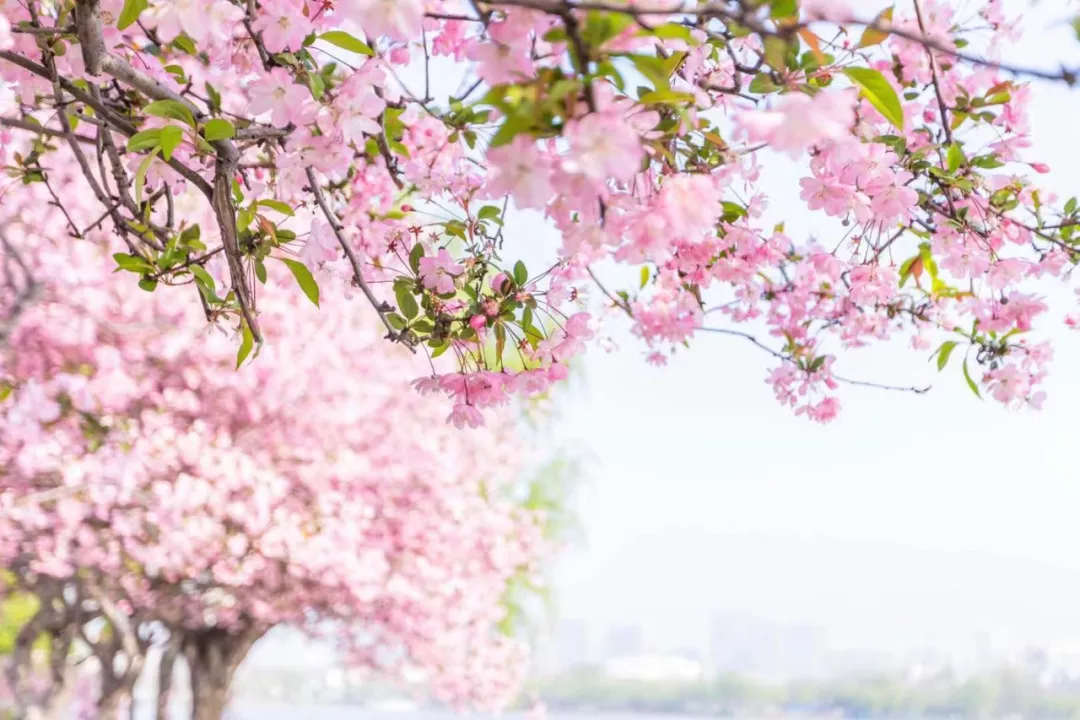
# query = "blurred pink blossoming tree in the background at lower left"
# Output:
<box><xmin>0</xmin><ymin>155</ymin><xmax>551</xmax><ymax>720</ymax></box>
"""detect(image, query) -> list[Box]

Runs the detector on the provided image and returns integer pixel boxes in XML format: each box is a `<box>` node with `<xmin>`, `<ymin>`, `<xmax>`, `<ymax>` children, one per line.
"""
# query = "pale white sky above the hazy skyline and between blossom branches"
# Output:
<box><xmin>540</xmin><ymin>0</ymin><xmax>1080</xmax><ymax>650</ymax></box>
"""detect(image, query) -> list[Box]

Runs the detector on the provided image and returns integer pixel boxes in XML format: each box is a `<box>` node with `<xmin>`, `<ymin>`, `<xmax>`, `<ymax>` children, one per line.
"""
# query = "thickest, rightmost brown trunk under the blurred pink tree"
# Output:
<box><xmin>181</xmin><ymin>627</ymin><xmax>266</xmax><ymax>720</ymax></box>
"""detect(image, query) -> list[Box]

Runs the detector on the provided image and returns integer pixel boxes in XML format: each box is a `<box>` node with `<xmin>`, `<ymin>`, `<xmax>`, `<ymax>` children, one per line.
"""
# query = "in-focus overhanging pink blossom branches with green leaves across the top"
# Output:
<box><xmin>0</xmin><ymin>0</ymin><xmax>1078</xmax><ymax>426</ymax></box>
